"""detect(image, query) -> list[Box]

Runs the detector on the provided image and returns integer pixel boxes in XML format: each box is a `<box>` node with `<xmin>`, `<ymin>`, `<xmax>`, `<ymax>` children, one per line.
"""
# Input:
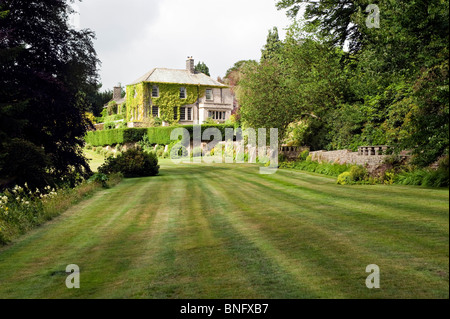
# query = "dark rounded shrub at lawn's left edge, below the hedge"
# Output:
<box><xmin>98</xmin><ymin>148</ymin><xmax>159</xmax><ymax>177</ymax></box>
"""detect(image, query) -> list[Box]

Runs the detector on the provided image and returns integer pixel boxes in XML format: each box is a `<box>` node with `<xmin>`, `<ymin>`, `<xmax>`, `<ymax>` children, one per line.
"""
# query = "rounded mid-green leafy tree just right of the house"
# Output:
<box><xmin>237</xmin><ymin>24</ymin><xmax>347</xmax><ymax>149</ymax></box>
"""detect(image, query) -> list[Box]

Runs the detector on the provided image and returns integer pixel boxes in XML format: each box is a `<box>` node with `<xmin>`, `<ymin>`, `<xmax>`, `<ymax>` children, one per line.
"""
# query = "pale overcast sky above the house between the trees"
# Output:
<box><xmin>75</xmin><ymin>0</ymin><xmax>290</xmax><ymax>90</ymax></box>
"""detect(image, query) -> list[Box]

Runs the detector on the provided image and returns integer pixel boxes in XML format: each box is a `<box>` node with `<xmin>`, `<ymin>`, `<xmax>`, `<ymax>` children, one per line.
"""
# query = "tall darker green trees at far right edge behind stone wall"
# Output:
<box><xmin>277</xmin><ymin>0</ymin><xmax>449</xmax><ymax>166</ymax></box>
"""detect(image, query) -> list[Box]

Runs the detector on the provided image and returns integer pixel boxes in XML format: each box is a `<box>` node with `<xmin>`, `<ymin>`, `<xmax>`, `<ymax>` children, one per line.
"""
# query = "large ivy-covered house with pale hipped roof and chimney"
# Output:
<box><xmin>126</xmin><ymin>57</ymin><xmax>233</xmax><ymax>125</ymax></box>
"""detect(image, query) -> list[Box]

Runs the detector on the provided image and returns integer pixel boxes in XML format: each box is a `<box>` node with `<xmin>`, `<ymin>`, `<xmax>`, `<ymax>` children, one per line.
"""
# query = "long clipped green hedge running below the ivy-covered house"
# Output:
<box><xmin>85</xmin><ymin>124</ymin><xmax>234</xmax><ymax>146</ymax></box>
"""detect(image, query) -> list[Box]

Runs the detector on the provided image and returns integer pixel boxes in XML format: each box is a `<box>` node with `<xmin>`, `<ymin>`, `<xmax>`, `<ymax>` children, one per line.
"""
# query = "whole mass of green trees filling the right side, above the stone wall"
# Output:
<box><xmin>237</xmin><ymin>0</ymin><xmax>449</xmax><ymax>166</ymax></box>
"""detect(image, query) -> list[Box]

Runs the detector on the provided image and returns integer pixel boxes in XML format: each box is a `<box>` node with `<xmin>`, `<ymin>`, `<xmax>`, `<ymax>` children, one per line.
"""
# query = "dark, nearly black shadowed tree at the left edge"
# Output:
<box><xmin>0</xmin><ymin>0</ymin><xmax>98</xmax><ymax>186</ymax></box>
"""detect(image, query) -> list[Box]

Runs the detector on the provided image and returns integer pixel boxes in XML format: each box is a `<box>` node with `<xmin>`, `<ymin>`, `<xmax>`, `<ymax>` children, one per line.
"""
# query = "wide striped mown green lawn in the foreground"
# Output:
<box><xmin>0</xmin><ymin>161</ymin><xmax>449</xmax><ymax>298</ymax></box>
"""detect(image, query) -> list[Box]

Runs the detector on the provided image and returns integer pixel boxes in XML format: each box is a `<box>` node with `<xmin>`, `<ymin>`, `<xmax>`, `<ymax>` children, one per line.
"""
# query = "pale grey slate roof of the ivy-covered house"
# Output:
<box><xmin>129</xmin><ymin>68</ymin><xmax>228</xmax><ymax>88</ymax></box>
